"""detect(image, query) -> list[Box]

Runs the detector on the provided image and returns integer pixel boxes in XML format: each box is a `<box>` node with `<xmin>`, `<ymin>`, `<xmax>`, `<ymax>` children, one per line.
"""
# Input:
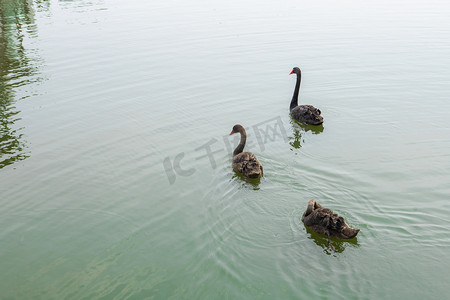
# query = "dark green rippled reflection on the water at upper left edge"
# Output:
<box><xmin>0</xmin><ymin>0</ymin><xmax>48</xmax><ymax>169</ymax></box>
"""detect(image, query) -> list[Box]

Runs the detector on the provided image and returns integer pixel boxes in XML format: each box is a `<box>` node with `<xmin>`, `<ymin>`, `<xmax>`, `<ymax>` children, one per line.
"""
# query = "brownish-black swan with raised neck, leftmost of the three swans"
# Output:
<box><xmin>230</xmin><ymin>125</ymin><xmax>264</xmax><ymax>178</ymax></box>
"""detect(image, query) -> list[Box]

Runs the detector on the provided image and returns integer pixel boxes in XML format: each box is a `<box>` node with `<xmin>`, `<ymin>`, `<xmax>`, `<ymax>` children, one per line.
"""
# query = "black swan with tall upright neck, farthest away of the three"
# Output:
<box><xmin>289</xmin><ymin>67</ymin><xmax>323</xmax><ymax>125</ymax></box>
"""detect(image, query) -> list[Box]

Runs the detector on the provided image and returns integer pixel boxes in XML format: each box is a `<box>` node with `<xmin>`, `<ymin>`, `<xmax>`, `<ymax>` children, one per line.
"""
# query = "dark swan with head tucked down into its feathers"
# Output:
<box><xmin>302</xmin><ymin>200</ymin><xmax>359</xmax><ymax>239</ymax></box>
